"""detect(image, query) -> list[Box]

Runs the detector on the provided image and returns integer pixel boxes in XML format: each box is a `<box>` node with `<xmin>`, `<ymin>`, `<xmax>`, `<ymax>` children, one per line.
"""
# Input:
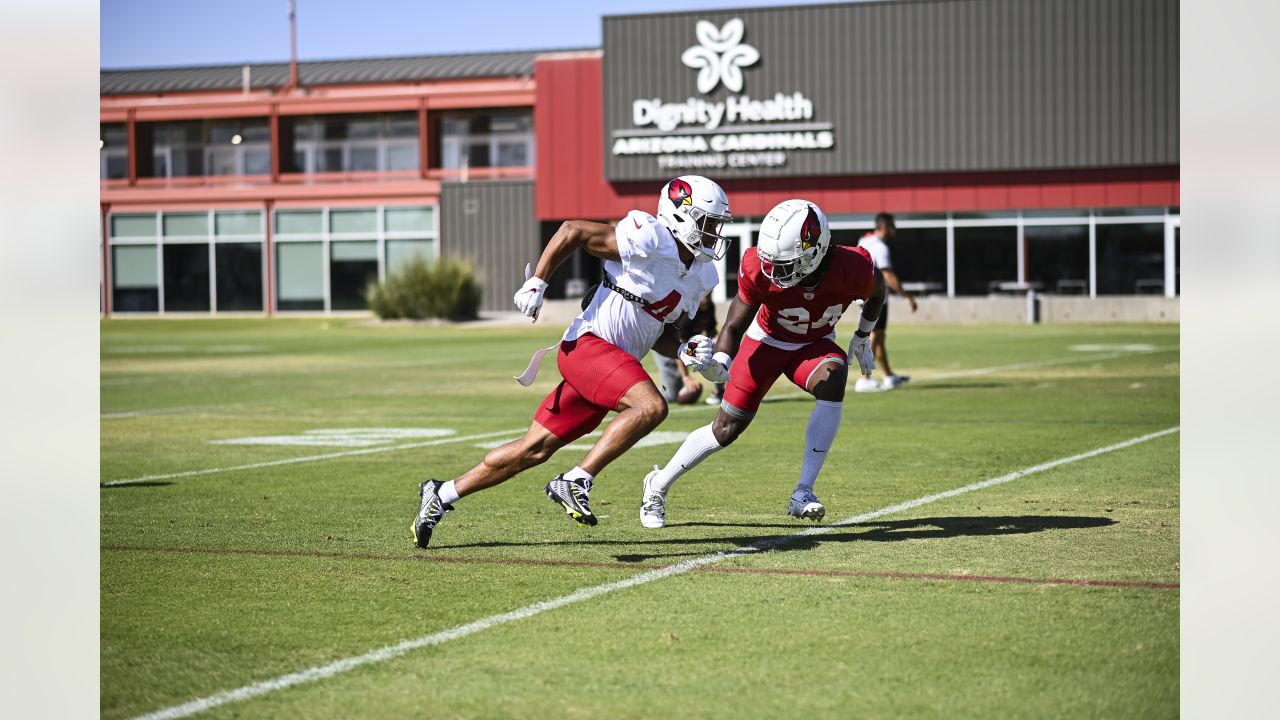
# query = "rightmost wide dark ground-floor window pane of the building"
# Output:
<box><xmin>1097</xmin><ymin>223</ymin><xmax>1165</xmax><ymax>295</ymax></box>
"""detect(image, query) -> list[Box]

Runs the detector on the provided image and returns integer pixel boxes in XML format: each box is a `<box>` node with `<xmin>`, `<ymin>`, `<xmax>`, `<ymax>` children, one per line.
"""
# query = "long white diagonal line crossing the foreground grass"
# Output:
<box><xmin>127</xmin><ymin>427</ymin><xmax>1179</xmax><ymax>720</ymax></box>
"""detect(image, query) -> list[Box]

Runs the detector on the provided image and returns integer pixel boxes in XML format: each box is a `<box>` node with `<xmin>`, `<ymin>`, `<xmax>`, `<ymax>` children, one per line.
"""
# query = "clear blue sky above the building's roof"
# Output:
<box><xmin>99</xmin><ymin>0</ymin><xmax>812</xmax><ymax>68</ymax></box>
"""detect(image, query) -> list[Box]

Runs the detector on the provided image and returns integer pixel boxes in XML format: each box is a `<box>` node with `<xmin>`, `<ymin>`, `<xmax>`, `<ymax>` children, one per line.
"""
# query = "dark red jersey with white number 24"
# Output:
<box><xmin>737</xmin><ymin>245</ymin><xmax>876</xmax><ymax>350</ymax></box>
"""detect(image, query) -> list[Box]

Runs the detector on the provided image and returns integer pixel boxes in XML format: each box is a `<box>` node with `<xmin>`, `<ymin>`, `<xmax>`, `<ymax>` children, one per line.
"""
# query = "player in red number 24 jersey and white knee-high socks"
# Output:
<box><xmin>640</xmin><ymin>200</ymin><xmax>886</xmax><ymax>528</ymax></box>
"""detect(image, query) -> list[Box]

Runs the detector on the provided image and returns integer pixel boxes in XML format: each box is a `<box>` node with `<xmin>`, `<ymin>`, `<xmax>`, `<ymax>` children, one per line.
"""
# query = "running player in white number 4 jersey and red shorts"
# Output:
<box><xmin>413</xmin><ymin>176</ymin><xmax>731</xmax><ymax>547</ymax></box>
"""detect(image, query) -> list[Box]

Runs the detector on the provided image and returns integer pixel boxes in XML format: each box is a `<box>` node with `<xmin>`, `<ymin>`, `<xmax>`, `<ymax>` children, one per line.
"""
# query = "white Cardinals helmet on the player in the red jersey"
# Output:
<box><xmin>755</xmin><ymin>200</ymin><xmax>831</xmax><ymax>287</ymax></box>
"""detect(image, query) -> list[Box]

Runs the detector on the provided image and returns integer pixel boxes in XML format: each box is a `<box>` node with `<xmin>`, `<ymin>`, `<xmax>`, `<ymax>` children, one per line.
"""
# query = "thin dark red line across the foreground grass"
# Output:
<box><xmin>102</xmin><ymin>544</ymin><xmax>1181</xmax><ymax>589</ymax></box>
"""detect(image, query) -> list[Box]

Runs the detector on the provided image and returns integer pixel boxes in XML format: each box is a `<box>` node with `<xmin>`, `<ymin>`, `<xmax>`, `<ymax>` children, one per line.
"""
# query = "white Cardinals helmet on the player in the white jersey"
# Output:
<box><xmin>658</xmin><ymin>176</ymin><xmax>733</xmax><ymax>263</ymax></box>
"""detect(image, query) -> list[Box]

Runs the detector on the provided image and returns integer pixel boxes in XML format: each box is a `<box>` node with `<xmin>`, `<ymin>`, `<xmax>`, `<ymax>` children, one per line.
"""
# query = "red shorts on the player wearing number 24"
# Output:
<box><xmin>724</xmin><ymin>337</ymin><xmax>849</xmax><ymax>416</ymax></box>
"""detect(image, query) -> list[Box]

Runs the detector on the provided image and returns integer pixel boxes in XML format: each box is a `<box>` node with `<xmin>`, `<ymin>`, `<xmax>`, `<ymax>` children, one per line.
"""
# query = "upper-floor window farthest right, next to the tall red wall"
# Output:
<box><xmin>436</xmin><ymin>109</ymin><xmax>534</xmax><ymax>169</ymax></box>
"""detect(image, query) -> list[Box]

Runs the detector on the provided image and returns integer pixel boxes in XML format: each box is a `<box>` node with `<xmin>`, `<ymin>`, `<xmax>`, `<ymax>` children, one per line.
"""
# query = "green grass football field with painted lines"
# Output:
<box><xmin>99</xmin><ymin>319</ymin><xmax>1180</xmax><ymax>720</ymax></box>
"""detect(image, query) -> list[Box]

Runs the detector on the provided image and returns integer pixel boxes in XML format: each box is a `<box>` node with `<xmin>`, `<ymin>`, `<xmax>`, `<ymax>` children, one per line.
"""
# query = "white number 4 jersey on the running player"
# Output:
<box><xmin>564</xmin><ymin>210</ymin><xmax>719</xmax><ymax>360</ymax></box>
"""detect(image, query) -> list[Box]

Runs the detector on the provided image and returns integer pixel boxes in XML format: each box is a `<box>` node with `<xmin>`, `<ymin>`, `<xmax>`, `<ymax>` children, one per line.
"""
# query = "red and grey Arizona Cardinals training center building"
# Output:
<box><xmin>100</xmin><ymin>0</ymin><xmax>1180</xmax><ymax>320</ymax></box>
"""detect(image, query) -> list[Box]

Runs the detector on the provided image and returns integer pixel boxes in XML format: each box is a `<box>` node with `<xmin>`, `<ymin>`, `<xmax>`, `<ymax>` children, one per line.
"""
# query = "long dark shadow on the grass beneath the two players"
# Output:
<box><xmin>440</xmin><ymin>515</ymin><xmax>1116</xmax><ymax>562</ymax></box>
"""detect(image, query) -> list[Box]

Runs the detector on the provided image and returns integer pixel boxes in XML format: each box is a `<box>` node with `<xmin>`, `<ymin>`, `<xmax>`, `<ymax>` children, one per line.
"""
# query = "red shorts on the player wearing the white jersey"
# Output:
<box><xmin>534</xmin><ymin>333</ymin><xmax>649</xmax><ymax>443</ymax></box>
